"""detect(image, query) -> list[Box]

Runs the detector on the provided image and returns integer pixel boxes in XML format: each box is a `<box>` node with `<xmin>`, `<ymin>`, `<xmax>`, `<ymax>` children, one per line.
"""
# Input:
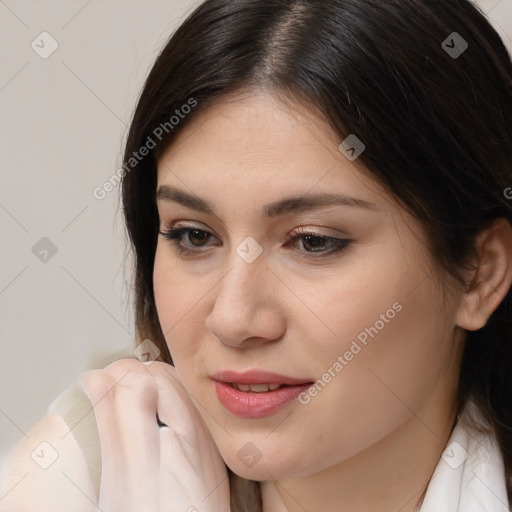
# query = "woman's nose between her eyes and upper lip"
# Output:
<box><xmin>205</xmin><ymin>243</ymin><xmax>286</xmax><ymax>348</ymax></box>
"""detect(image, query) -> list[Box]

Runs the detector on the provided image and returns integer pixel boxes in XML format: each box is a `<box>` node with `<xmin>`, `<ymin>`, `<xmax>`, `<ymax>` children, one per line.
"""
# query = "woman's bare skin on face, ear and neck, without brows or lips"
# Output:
<box><xmin>154</xmin><ymin>92</ymin><xmax>512</xmax><ymax>512</ymax></box>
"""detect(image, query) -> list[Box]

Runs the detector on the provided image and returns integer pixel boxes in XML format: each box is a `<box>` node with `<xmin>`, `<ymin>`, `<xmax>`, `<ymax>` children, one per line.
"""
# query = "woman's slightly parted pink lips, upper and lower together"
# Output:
<box><xmin>211</xmin><ymin>370</ymin><xmax>313</xmax><ymax>418</ymax></box>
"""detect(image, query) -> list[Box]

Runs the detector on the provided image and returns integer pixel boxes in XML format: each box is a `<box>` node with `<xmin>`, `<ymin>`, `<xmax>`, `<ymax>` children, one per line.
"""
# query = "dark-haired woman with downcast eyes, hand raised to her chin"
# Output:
<box><xmin>0</xmin><ymin>0</ymin><xmax>512</xmax><ymax>512</ymax></box>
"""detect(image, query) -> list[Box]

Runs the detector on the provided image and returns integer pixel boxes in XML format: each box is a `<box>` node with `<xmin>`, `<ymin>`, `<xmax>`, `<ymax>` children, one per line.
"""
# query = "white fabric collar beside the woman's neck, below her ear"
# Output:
<box><xmin>418</xmin><ymin>402</ymin><xmax>509</xmax><ymax>512</ymax></box>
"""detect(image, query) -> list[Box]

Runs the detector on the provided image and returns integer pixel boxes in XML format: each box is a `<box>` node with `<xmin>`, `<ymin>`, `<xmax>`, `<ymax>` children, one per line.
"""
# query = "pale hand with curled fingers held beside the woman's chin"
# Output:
<box><xmin>81</xmin><ymin>359</ymin><xmax>230</xmax><ymax>512</ymax></box>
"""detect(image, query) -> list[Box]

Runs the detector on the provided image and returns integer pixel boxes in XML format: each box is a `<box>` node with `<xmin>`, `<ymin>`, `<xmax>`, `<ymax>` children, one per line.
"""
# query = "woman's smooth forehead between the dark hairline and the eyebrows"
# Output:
<box><xmin>158</xmin><ymin>93</ymin><xmax>393</xmax><ymax>211</ymax></box>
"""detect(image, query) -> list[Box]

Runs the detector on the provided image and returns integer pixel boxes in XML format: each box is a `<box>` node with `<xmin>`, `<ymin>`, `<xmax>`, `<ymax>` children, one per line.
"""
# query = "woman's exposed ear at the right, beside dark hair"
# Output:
<box><xmin>456</xmin><ymin>218</ymin><xmax>512</xmax><ymax>331</ymax></box>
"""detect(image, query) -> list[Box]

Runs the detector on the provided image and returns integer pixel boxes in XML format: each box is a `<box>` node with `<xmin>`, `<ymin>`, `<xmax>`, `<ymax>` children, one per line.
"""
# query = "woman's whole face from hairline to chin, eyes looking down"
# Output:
<box><xmin>154</xmin><ymin>93</ymin><xmax>461</xmax><ymax>480</ymax></box>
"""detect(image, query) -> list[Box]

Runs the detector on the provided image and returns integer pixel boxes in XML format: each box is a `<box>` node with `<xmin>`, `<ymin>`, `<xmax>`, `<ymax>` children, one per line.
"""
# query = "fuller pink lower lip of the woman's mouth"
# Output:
<box><xmin>215</xmin><ymin>381</ymin><xmax>312</xmax><ymax>418</ymax></box>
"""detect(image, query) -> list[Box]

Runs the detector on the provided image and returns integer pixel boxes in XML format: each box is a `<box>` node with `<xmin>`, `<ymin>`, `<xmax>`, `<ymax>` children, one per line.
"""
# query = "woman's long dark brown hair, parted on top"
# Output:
<box><xmin>118</xmin><ymin>0</ymin><xmax>512</xmax><ymax>511</ymax></box>
